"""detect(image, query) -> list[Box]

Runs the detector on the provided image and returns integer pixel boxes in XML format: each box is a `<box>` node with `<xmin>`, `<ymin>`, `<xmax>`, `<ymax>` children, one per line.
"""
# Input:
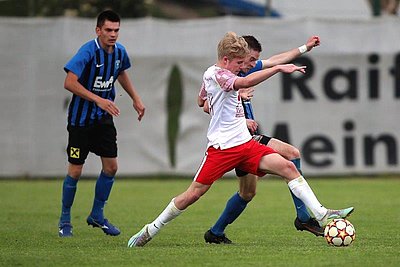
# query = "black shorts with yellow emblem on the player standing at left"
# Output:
<box><xmin>67</xmin><ymin>118</ymin><xmax>118</xmax><ymax>165</ymax></box>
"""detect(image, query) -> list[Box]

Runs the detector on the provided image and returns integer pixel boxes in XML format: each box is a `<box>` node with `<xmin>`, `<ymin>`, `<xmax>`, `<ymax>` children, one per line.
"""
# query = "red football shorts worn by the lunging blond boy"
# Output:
<box><xmin>194</xmin><ymin>139</ymin><xmax>276</xmax><ymax>185</ymax></box>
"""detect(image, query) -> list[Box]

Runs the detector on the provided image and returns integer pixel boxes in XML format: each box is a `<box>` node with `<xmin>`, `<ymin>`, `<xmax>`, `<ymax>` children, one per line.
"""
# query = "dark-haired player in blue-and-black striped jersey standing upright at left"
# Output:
<box><xmin>59</xmin><ymin>10</ymin><xmax>145</xmax><ymax>237</ymax></box>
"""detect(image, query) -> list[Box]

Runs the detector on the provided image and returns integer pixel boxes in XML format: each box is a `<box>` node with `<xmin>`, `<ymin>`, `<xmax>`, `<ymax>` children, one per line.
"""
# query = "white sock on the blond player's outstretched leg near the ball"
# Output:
<box><xmin>288</xmin><ymin>176</ymin><xmax>328</xmax><ymax>220</ymax></box>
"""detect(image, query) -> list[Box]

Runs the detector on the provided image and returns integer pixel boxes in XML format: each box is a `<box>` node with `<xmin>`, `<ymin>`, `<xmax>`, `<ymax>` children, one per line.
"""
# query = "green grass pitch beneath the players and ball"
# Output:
<box><xmin>0</xmin><ymin>178</ymin><xmax>400</xmax><ymax>266</ymax></box>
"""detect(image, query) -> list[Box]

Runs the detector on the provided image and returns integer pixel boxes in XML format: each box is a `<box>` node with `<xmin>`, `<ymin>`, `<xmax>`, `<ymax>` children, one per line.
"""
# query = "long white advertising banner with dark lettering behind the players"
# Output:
<box><xmin>0</xmin><ymin>17</ymin><xmax>400</xmax><ymax>177</ymax></box>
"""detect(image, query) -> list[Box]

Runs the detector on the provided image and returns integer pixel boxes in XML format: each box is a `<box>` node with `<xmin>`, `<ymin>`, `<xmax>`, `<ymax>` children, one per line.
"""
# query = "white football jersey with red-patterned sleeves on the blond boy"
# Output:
<box><xmin>199</xmin><ymin>65</ymin><xmax>251</xmax><ymax>149</ymax></box>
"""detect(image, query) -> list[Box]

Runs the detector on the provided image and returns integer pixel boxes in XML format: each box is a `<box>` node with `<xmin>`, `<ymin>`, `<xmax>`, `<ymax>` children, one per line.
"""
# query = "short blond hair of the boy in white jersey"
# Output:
<box><xmin>218</xmin><ymin>32</ymin><xmax>250</xmax><ymax>60</ymax></box>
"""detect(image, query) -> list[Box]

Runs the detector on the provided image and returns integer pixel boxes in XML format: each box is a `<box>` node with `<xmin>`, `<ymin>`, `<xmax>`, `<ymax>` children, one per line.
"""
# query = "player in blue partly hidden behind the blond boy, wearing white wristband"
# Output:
<box><xmin>203</xmin><ymin>36</ymin><xmax>323</xmax><ymax>244</ymax></box>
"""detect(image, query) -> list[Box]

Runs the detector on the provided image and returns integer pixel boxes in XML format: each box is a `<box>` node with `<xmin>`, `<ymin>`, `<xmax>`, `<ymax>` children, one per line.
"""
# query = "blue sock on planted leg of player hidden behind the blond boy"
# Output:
<box><xmin>211</xmin><ymin>193</ymin><xmax>248</xmax><ymax>236</ymax></box>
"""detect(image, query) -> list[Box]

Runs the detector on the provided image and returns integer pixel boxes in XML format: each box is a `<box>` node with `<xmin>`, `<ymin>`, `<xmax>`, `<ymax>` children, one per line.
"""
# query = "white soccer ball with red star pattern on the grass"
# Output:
<box><xmin>324</xmin><ymin>219</ymin><xmax>356</xmax><ymax>247</ymax></box>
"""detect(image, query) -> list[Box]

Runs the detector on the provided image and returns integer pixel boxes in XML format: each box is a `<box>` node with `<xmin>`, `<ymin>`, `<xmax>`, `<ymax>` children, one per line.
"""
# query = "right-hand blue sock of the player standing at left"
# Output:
<box><xmin>90</xmin><ymin>172</ymin><xmax>114</xmax><ymax>223</ymax></box>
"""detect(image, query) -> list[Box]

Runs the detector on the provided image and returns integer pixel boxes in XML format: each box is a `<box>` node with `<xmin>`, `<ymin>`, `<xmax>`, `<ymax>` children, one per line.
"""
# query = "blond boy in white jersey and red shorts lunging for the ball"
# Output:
<box><xmin>128</xmin><ymin>32</ymin><xmax>353</xmax><ymax>247</ymax></box>
